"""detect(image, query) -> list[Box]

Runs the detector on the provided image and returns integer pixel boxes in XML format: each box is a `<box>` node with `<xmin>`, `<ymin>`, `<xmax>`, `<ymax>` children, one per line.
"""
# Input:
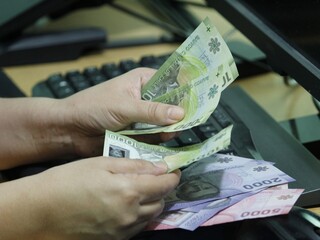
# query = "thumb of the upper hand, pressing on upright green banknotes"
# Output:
<box><xmin>131</xmin><ymin>100</ymin><xmax>184</xmax><ymax>125</ymax></box>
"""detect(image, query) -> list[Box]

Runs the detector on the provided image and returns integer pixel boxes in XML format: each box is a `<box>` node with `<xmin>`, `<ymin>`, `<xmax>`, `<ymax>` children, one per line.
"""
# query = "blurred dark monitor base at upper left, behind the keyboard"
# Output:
<box><xmin>0</xmin><ymin>28</ymin><xmax>107</xmax><ymax>66</ymax></box>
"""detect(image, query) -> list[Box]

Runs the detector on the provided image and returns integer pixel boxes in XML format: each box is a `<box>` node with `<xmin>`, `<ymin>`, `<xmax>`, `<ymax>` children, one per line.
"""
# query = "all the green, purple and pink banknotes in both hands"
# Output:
<box><xmin>103</xmin><ymin>18</ymin><xmax>303</xmax><ymax>230</ymax></box>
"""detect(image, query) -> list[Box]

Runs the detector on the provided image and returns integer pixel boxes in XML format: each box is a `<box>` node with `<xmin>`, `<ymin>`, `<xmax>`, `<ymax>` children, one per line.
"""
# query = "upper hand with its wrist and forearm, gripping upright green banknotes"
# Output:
<box><xmin>0</xmin><ymin>68</ymin><xmax>184</xmax><ymax>170</ymax></box>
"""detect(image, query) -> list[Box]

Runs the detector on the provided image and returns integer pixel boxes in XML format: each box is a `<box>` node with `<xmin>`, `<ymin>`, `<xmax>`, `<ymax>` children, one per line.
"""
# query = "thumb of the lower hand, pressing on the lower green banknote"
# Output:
<box><xmin>103</xmin><ymin>157</ymin><xmax>168</xmax><ymax>175</ymax></box>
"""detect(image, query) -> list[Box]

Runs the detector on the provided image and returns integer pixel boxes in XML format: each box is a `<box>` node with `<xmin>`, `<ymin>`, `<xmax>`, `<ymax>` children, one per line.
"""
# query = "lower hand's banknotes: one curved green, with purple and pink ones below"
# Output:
<box><xmin>104</xmin><ymin>135</ymin><xmax>303</xmax><ymax>230</ymax></box>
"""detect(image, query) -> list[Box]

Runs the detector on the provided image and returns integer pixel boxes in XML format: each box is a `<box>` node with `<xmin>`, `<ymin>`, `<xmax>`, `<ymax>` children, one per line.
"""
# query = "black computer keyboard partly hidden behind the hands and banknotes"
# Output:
<box><xmin>32</xmin><ymin>54</ymin><xmax>261</xmax><ymax>159</ymax></box>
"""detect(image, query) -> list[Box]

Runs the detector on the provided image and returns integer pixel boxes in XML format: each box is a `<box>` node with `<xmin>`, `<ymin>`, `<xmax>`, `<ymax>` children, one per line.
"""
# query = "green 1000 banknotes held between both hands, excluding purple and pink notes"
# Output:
<box><xmin>103</xmin><ymin>18</ymin><xmax>238</xmax><ymax>172</ymax></box>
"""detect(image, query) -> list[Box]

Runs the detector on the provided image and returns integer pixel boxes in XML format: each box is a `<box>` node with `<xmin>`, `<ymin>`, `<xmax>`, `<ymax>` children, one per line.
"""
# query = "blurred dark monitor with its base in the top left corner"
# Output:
<box><xmin>0</xmin><ymin>0</ymin><xmax>109</xmax><ymax>66</ymax></box>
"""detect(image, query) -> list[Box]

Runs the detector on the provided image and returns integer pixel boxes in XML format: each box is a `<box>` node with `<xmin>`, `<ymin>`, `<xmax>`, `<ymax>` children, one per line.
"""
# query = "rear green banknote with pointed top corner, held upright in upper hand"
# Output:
<box><xmin>142</xmin><ymin>17</ymin><xmax>238</xmax><ymax>101</ymax></box>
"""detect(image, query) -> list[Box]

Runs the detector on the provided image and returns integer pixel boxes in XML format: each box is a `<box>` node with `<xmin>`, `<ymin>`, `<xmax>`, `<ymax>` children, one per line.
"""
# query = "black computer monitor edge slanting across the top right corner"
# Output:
<box><xmin>207</xmin><ymin>0</ymin><xmax>320</xmax><ymax>100</ymax></box>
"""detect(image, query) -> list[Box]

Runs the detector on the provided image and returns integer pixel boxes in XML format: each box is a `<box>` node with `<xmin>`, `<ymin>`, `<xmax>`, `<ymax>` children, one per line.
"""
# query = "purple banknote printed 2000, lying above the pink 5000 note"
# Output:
<box><xmin>165</xmin><ymin>161</ymin><xmax>294</xmax><ymax>210</ymax></box>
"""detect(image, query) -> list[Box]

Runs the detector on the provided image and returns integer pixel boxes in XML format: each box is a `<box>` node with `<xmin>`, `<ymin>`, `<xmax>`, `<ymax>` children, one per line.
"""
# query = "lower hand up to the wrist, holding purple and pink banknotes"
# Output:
<box><xmin>28</xmin><ymin>157</ymin><xmax>180</xmax><ymax>240</ymax></box>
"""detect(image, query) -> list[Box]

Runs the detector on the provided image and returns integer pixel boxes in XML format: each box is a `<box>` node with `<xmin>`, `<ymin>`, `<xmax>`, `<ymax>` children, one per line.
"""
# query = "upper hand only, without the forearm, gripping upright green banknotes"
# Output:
<box><xmin>63</xmin><ymin>68</ymin><xmax>184</xmax><ymax>157</ymax></box>
